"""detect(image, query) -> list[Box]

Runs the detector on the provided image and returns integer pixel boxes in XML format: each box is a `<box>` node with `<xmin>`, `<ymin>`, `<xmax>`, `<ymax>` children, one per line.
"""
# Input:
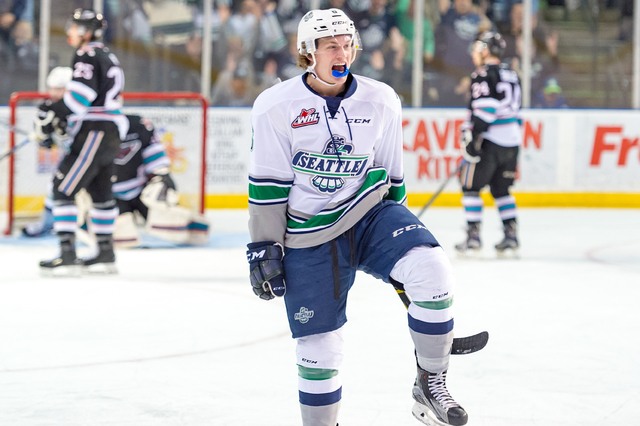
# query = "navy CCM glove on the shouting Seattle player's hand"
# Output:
<box><xmin>247</xmin><ymin>241</ymin><xmax>286</xmax><ymax>300</ymax></box>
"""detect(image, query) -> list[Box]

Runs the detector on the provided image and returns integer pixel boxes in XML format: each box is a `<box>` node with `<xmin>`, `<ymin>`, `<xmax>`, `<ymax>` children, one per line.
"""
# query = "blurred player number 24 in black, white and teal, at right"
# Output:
<box><xmin>455</xmin><ymin>31</ymin><xmax>522</xmax><ymax>255</ymax></box>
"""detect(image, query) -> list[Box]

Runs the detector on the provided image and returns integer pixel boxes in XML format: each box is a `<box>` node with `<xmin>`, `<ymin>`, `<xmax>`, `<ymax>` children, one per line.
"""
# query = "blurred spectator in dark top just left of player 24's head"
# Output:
<box><xmin>433</xmin><ymin>0</ymin><xmax>493</xmax><ymax>106</ymax></box>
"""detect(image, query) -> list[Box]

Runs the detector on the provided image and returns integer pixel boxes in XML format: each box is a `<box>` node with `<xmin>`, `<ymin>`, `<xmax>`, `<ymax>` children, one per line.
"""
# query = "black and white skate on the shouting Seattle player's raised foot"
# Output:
<box><xmin>411</xmin><ymin>367</ymin><xmax>468</xmax><ymax>426</ymax></box>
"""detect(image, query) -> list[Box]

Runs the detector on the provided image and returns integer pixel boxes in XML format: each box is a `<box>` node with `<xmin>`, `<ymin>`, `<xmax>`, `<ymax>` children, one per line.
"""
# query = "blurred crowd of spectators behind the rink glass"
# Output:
<box><xmin>0</xmin><ymin>0</ymin><xmax>627</xmax><ymax>107</ymax></box>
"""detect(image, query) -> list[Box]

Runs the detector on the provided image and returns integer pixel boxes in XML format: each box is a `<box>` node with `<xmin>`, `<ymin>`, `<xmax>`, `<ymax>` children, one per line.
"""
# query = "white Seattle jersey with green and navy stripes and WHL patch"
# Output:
<box><xmin>249</xmin><ymin>74</ymin><xmax>406</xmax><ymax>248</ymax></box>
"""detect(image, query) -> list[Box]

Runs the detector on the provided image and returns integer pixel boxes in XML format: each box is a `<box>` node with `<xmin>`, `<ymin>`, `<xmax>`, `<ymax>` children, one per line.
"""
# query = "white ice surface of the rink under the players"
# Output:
<box><xmin>0</xmin><ymin>208</ymin><xmax>640</xmax><ymax>426</ymax></box>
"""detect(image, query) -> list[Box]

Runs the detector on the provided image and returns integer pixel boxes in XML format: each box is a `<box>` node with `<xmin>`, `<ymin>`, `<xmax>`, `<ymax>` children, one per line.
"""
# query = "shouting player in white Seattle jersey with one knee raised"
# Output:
<box><xmin>247</xmin><ymin>9</ymin><xmax>467</xmax><ymax>426</ymax></box>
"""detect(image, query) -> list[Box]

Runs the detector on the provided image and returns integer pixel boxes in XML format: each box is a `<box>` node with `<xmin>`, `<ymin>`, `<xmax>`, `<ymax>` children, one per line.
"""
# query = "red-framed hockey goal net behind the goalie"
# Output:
<box><xmin>0</xmin><ymin>92</ymin><xmax>208</xmax><ymax>235</ymax></box>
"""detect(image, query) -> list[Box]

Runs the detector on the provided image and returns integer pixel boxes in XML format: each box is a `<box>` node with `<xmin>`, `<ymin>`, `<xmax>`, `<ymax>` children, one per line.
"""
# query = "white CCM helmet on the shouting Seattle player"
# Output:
<box><xmin>297</xmin><ymin>9</ymin><xmax>362</xmax><ymax>55</ymax></box>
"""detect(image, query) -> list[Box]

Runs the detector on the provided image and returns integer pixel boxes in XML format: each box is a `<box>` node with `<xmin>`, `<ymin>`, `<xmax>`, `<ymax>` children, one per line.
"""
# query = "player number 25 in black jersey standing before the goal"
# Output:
<box><xmin>40</xmin><ymin>9</ymin><xmax>127</xmax><ymax>274</ymax></box>
